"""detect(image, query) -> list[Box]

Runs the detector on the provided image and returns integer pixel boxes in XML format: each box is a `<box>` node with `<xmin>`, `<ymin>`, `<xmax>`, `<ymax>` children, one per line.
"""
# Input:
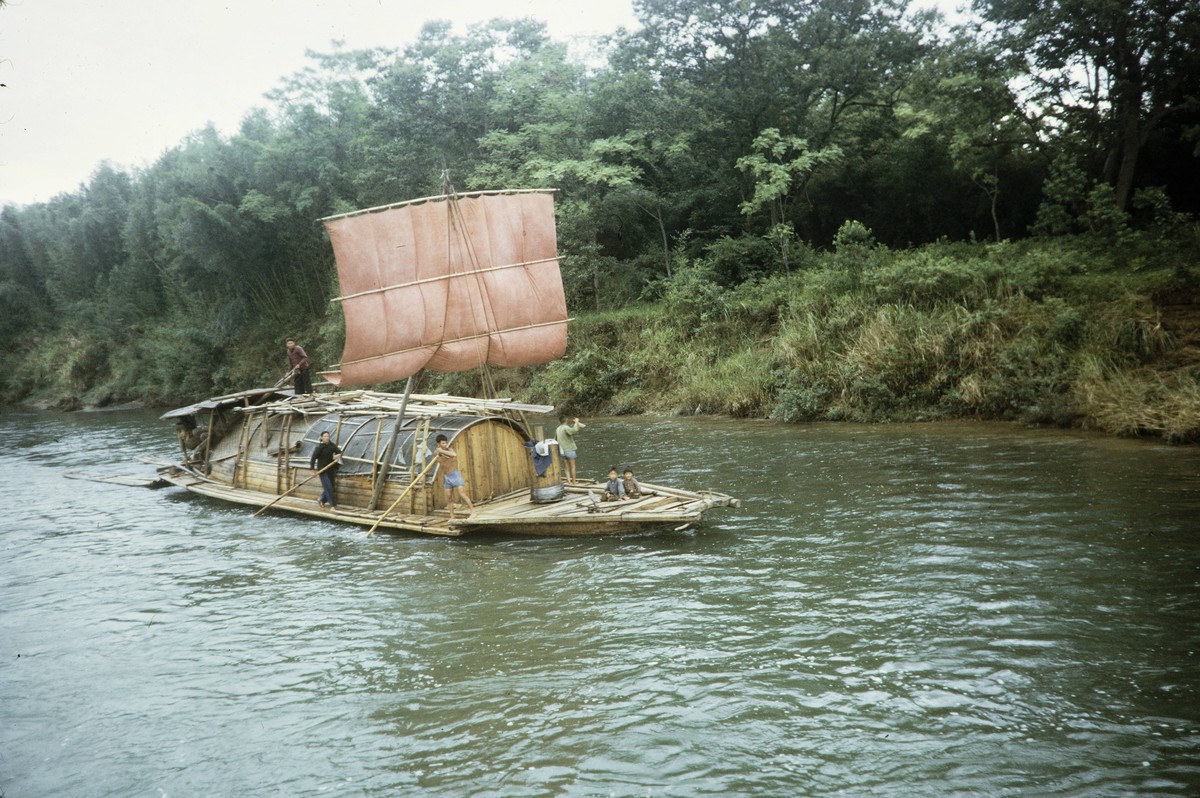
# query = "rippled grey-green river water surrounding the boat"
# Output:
<box><xmin>0</xmin><ymin>410</ymin><xmax>1200</xmax><ymax>798</ymax></box>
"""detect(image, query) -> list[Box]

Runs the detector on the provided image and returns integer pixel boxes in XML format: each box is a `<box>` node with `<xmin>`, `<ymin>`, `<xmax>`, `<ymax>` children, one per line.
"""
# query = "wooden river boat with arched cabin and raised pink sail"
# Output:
<box><xmin>158</xmin><ymin>184</ymin><xmax>738</xmax><ymax>536</ymax></box>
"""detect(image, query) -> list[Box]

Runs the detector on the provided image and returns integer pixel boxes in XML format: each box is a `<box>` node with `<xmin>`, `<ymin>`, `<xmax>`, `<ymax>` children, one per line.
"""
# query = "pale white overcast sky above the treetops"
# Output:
<box><xmin>0</xmin><ymin>0</ymin><xmax>952</xmax><ymax>206</ymax></box>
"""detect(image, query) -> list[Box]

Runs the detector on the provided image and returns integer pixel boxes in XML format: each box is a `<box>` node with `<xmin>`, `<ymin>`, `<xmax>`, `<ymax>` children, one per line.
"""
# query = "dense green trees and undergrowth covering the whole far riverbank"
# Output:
<box><xmin>0</xmin><ymin>0</ymin><xmax>1200</xmax><ymax>437</ymax></box>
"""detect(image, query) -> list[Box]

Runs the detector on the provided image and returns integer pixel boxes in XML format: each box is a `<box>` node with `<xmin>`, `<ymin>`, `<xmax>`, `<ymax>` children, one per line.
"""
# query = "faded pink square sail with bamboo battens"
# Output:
<box><xmin>322</xmin><ymin>191</ymin><xmax>568</xmax><ymax>385</ymax></box>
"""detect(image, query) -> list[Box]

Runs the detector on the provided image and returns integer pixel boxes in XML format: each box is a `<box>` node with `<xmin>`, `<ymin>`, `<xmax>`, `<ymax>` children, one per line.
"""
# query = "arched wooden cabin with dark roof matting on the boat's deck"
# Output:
<box><xmin>163</xmin><ymin>390</ymin><xmax>562</xmax><ymax>516</ymax></box>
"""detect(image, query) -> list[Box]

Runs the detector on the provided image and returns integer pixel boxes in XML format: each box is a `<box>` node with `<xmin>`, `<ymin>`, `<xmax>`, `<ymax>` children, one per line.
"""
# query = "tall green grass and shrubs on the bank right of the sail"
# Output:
<box><xmin>534</xmin><ymin>231</ymin><xmax>1198</xmax><ymax>440</ymax></box>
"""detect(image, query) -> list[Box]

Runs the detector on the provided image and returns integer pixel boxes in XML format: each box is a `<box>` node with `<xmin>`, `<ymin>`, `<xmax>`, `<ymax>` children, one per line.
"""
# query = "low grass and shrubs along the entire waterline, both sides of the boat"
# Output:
<box><xmin>9</xmin><ymin>223</ymin><xmax>1200</xmax><ymax>443</ymax></box>
